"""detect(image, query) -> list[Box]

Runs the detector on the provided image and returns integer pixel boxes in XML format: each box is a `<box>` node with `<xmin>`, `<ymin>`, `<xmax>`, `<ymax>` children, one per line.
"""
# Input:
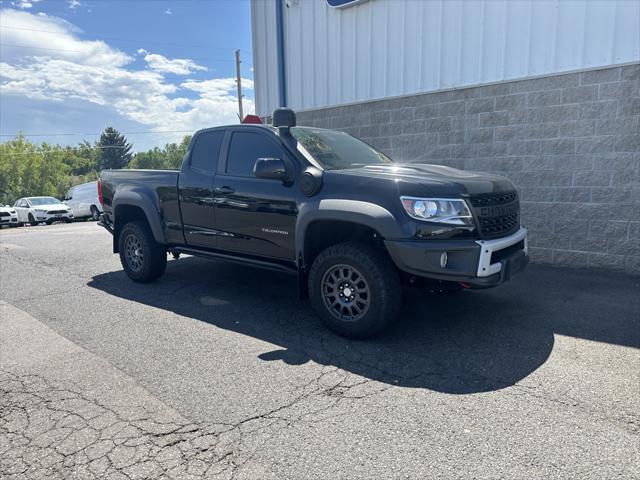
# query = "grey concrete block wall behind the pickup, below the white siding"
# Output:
<box><xmin>298</xmin><ymin>64</ymin><xmax>640</xmax><ymax>273</ymax></box>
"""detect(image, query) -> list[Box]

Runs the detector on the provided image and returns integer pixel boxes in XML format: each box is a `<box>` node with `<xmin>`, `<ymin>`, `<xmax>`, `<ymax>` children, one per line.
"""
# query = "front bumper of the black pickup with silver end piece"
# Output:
<box><xmin>385</xmin><ymin>228</ymin><xmax>529</xmax><ymax>288</ymax></box>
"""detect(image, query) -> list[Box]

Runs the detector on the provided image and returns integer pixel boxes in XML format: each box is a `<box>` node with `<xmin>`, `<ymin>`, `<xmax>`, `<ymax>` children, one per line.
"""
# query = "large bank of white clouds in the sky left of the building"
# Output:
<box><xmin>0</xmin><ymin>10</ymin><xmax>254</xmax><ymax>141</ymax></box>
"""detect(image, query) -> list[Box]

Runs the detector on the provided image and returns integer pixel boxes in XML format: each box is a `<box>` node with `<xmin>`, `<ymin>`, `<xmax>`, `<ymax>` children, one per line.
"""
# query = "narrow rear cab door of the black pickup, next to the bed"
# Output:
<box><xmin>178</xmin><ymin>128</ymin><xmax>225</xmax><ymax>248</ymax></box>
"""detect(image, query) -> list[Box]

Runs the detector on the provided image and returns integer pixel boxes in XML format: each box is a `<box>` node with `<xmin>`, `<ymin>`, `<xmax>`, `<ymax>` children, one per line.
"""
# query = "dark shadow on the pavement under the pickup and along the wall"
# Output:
<box><xmin>89</xmin><ymin>257</ymin><xmax>640</xmax><ymax>394</ymax></box>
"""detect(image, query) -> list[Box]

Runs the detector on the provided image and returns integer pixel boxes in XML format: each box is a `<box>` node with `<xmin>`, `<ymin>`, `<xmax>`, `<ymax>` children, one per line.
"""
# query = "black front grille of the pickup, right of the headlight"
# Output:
<box><xmin>469</xmin><ymin>192</ymin><xmax>520</xmax><ymax>238</ymax></box>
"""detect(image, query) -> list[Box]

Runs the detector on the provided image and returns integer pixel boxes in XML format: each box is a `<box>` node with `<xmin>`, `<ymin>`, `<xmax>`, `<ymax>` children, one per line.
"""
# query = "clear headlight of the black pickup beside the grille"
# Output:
<box><xmin>400</xmin><ymin>197</ymin><xmax>474</xmax><ymax>227</ymax></box>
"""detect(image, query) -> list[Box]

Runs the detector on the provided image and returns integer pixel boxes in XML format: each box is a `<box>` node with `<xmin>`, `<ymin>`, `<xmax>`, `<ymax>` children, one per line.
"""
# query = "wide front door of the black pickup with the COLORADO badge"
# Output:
<box><xmin>213</xmin><ymin>126</ymin><xmax>298</xmax><ymax>260</ymax></box>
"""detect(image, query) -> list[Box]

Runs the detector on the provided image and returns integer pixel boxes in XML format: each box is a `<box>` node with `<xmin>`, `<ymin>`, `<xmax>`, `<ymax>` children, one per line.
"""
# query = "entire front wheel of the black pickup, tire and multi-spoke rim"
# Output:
<box><xmin>309</xmin><ymin>242</ymin><xmax>402</xmax><ymax>338</ymax></box>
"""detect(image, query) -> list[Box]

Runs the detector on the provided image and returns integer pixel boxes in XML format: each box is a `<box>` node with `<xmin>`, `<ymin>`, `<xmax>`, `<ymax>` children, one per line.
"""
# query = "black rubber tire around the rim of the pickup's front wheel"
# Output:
<box><xmin>309</xmin><ymin>242</ymin><xmax>402</xmax><ymax>338</ymax></box>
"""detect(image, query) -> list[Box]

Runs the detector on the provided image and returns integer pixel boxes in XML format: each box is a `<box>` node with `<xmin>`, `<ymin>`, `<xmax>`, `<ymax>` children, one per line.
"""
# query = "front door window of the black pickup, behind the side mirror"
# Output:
<box><xmin>227</xmin><ymin>132</ymin><xmax>284</xmax><ymax>177</ymax></box>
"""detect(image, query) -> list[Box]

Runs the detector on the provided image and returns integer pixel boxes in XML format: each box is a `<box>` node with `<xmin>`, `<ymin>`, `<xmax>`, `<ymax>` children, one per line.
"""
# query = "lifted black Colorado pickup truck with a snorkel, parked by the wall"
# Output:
<box><xmin>99</xmin><ymin>109</ymin><xmax>528</xmax><ymax>337</ymax></box>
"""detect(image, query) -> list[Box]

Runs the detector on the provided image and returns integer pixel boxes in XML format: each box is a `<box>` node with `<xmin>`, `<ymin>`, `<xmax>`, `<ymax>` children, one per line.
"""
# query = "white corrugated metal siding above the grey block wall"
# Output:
<box><xmin>251</xmin><ymin>0</ymin><xmax>640</xmax><ymax>115</ymax></box>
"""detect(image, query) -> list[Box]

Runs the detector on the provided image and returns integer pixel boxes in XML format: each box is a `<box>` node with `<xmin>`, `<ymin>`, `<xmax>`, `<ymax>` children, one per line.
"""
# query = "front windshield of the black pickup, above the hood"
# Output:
<box><xmin>291</xmin><ymin>127</ymin><xmax>393</xmax><ymax>170</ymax></box>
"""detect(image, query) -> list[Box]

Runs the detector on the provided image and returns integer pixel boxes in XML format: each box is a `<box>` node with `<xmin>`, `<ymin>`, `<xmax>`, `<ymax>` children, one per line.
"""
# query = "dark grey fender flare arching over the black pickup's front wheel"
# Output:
<box><xmin>295</xmin><ymin>199</ymin><xmax>403</xmax><ymax>269</ymax></box>
